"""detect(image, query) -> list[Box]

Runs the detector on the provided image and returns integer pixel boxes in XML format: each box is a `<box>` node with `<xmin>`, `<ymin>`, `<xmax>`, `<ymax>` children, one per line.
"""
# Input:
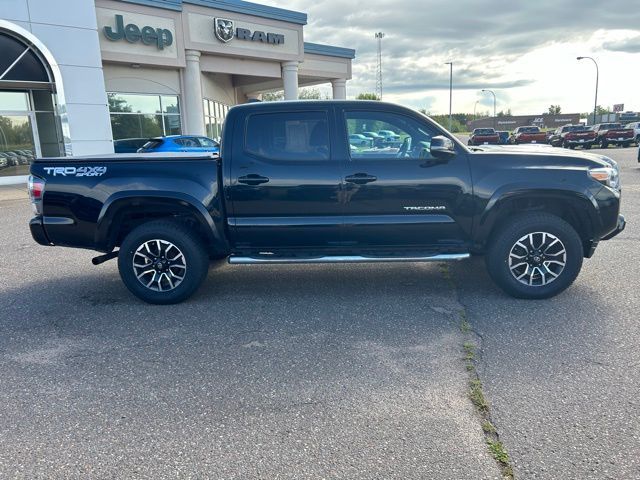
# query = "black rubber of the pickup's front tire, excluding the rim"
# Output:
<box><xmin>485</xmin><ymin>214</ymin><xmax>584</xmax><ymax>299</ymax></box>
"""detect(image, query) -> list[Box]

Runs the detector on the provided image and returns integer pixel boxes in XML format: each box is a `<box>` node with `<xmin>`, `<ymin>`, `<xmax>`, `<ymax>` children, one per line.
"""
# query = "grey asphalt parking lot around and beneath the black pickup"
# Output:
<box><xmin>0</xmin><ymin>144</ymin><xmax>640</xmax><ymax>479</ymax></box>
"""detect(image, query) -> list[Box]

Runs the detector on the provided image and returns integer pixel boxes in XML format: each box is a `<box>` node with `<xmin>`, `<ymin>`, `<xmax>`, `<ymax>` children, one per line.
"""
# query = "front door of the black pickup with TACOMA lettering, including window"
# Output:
<box><xmin>340</xmin><ymin>106</ymin><xmax>472</xmax><ymax>253</ymax></box>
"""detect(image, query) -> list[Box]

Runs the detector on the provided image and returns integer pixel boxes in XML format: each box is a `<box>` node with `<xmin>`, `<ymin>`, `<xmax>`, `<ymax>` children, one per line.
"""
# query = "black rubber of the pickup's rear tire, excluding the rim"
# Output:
<box><xmin>118</xmin><ymin>221</ymin><xmax>209</xmax><ymax>305</ymax></box>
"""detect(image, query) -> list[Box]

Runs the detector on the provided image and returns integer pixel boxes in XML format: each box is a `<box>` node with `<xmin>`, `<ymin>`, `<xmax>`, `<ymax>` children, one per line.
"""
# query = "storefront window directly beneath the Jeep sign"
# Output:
<box><xmin>107</xmin><ymin>93</ymin><xmax>182</xmax><ymax>140</ymax></box>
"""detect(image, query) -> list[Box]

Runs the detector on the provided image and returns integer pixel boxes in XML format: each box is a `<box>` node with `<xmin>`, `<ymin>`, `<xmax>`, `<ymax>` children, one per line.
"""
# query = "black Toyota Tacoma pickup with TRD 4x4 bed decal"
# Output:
<box><xmin>29</xmin><ymin>101</ymin><xmax>625</xmax><ymax>304</ymax></box>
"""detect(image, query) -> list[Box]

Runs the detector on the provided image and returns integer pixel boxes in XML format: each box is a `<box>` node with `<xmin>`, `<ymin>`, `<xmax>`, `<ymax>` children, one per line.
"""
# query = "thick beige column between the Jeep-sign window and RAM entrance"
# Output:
<box><xmin>182</xmin><ymin>50</ymin><xmax>205</xmax><ymax>135</ymax></box>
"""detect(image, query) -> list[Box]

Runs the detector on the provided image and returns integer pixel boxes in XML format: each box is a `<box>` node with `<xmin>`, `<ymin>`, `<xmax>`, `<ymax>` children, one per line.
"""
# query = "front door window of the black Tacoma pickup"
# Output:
<box><xmin>345</xmin><ymin>111</ymin><xmax>438</xmax><ymax>159</ymax></box>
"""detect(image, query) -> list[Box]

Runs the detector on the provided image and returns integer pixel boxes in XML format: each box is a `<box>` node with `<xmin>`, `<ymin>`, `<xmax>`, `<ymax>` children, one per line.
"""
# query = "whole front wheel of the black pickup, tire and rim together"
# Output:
<box><xmin>485</xmin><ymin>213</ymin><xmax>583</xmax><ymax>299</ymax></box>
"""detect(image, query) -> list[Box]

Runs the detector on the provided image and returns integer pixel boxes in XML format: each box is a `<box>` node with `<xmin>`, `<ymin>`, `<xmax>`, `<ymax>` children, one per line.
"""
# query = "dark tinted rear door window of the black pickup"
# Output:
<box><xmin>245</xmin><ymin>112</ymin><xmax>329</xmax><ymax>160</ymax></box>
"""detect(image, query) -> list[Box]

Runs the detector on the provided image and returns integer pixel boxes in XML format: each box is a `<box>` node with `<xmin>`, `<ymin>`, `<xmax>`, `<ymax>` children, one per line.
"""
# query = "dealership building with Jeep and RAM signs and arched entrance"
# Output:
<box><xmin>0</xmin><ymin>0</ymin><xmax>355</xmax><ymax>183</ymax></box>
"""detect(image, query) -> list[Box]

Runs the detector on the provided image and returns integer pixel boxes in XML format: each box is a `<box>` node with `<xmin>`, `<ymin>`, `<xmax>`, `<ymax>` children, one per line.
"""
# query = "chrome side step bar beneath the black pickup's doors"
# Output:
<box><xmin>229</xmin><ymin>253</ymin><xmax>471</xmax><ymax>265</ymax></box>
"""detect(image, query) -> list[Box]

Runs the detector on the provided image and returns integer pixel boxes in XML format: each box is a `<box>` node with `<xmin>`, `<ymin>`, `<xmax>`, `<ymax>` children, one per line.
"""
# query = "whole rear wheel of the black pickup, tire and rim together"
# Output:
<box><xmin>118</xmin><ymin>220</ymin><xmax>209</xmax><ymax>305</ymax></box>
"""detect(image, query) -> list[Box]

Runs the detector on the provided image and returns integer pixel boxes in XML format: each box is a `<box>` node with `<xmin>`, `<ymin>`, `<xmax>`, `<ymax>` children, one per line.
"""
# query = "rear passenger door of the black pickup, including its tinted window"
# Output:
<box><xmin>223</xmin><ymin>104</ymin><xmax>342</xmax><ymax>251</ymax></box>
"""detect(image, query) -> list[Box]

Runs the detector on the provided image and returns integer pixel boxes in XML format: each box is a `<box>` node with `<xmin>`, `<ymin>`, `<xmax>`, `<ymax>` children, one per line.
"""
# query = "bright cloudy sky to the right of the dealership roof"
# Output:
<box><xmin>265</xmin><ymin>0</ymin><xmax>640</xmax><ymax>114</ymax></box>
